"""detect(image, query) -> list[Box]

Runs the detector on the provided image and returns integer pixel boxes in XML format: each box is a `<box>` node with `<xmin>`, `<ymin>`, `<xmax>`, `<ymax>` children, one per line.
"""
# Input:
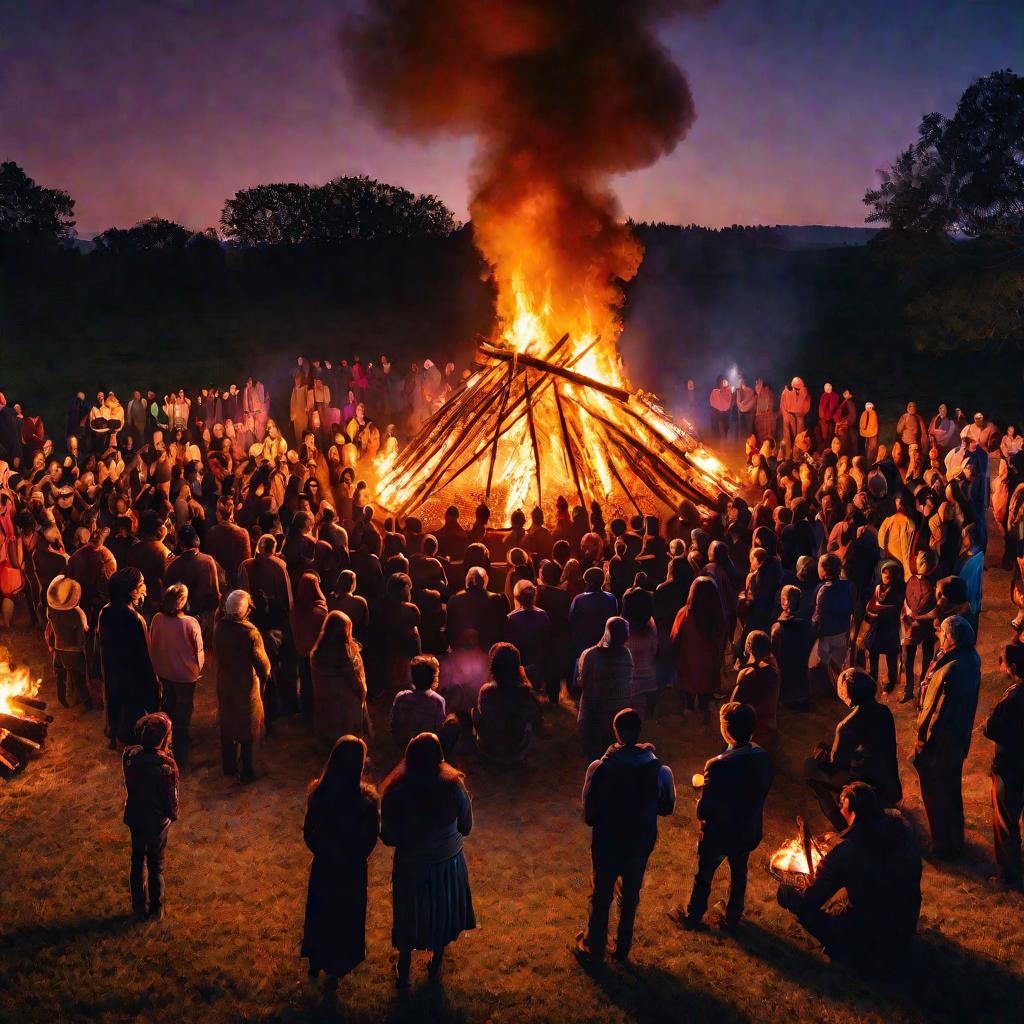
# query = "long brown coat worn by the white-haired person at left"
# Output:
<box><xmin>213</xmin><ymin>618</ymin><xmax>270</xmax><ymax>743</ymax></box>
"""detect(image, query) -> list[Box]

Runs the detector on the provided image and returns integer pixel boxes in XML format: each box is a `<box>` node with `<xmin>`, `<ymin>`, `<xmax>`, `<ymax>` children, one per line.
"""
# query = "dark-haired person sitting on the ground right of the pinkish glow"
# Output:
<box><xmin>473</xmin><ymin>643</ymin><xmax>541</xmax><ymax>764</ymax></box>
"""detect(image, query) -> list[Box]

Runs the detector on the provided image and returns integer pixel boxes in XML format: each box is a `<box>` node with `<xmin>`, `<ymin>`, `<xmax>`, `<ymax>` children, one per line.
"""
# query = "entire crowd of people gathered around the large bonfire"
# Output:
<box><xmin>0</xmin><ymin>358</ymin><xmax>1024</xmax><ymax>986</ymax></box>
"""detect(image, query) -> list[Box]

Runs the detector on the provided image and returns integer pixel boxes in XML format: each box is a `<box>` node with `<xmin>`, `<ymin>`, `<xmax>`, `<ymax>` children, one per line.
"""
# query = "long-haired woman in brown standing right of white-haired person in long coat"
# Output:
<box><xmin>309</xmin><ymin>611</ymin><xmax>370</xmax><ymax>740</ymax></box>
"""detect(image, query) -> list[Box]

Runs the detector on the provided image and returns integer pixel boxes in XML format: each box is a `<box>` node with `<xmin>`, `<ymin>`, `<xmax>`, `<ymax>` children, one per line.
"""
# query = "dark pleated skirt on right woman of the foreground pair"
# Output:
<box><xmin>391</xmin><ymin>850</ymin><xmax>476</xmax><ymax>952</ymax></box>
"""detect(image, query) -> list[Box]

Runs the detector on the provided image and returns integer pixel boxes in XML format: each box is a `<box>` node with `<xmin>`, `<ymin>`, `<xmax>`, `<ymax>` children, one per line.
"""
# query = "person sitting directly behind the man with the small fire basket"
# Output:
<box><xmin>804</xmin><ymin>669</ymin><xmax>903</xmax><ymax>831</ymax></box>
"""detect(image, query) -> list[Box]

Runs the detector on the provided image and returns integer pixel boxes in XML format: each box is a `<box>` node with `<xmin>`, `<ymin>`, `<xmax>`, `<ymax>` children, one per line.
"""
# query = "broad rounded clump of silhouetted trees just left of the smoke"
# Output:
<box><xmin>220</xmin><ymin>175</ymin><xmax>459</xmax><ymax>246</ymax></box>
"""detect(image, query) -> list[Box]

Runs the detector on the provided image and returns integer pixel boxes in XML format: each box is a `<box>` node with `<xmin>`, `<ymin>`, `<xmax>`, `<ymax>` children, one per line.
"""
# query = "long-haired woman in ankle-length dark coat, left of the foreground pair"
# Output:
<box><xmin>301</xmin><ymin>736</ymin><xmax>380</xmax><ymax>988</ymax></box>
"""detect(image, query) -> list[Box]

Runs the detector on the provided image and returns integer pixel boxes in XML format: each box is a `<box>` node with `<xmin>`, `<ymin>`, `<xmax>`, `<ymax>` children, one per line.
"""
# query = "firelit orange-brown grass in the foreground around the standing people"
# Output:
<box><xmin>0</xmin><ymin>569</ymin><xmax>1024</xmax><ymax>1024</ymax></box>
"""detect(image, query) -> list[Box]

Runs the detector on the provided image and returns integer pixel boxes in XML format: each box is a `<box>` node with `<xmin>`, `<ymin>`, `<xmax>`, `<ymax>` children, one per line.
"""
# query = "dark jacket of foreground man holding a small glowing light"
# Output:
<box><xmin>697</xmin><ymin>743</ymin><xmax>774</xmax><ymax>853</ymax></box>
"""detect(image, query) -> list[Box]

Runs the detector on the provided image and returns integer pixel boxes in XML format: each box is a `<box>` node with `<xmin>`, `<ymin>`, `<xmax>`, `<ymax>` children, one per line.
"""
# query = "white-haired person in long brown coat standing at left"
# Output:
<box><xmin>213</xmin><ymin>590</ymin><xmax>270</xmax><ymax>782</ymax></box>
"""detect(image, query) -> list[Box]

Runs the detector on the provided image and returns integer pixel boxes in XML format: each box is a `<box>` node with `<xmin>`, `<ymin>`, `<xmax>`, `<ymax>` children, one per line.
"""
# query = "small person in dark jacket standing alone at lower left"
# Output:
<box><xmin>122</xmin><ymin>713</ymin><xmax>178</xmax><ymax>921</ymax></box>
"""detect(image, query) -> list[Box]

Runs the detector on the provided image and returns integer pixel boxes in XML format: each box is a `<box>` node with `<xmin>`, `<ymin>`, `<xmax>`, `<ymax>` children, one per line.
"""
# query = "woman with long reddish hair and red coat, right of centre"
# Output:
<box><xmin>671</xmin><ymin>575</ymin><xmax>725</xmax><ymax>721</ymax></box>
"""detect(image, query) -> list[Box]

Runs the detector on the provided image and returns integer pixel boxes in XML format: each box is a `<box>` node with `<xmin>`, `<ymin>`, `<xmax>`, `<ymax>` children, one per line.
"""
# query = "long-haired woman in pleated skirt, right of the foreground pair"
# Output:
<box><xmin>381</xmin><ymin>732</ymin><xmax>476</xmax><ymax>988</ymax></box>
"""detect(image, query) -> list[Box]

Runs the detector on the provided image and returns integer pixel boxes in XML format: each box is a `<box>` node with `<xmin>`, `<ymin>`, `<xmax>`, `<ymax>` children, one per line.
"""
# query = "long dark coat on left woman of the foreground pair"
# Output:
<box><xmin>301</xmin><ymin>790</ymin><xmax>380</xmax><ymax>977</ymax></box>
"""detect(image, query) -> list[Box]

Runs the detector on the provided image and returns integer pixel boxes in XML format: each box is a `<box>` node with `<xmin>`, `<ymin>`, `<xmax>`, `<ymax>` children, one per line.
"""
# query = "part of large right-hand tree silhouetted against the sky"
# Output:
<box><xmin>864</xmin><ymin>71</ymin><xmax>1024</xmax><ymax>236</ymax></box>
